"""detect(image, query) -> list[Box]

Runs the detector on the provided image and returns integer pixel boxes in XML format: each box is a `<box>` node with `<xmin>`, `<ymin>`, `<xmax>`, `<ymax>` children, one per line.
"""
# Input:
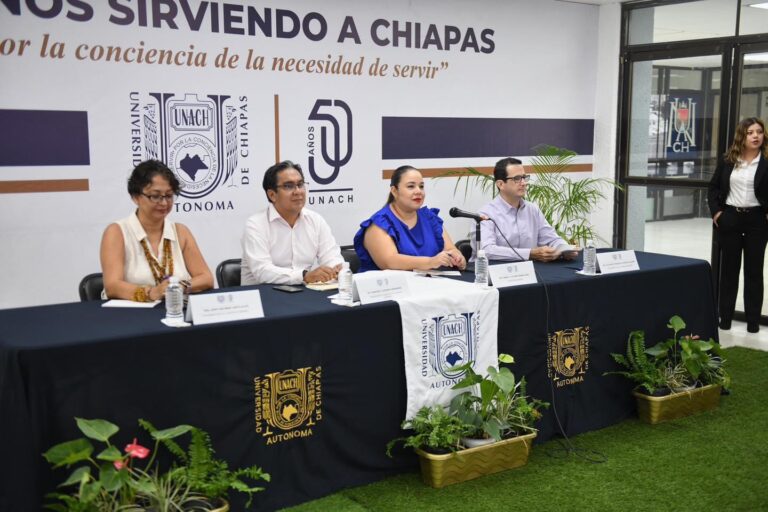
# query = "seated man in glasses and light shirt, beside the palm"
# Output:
<box><xmin>480</xmin><ymin>158</ymin><xmax>576</xmax><ymax>261</ymax></box>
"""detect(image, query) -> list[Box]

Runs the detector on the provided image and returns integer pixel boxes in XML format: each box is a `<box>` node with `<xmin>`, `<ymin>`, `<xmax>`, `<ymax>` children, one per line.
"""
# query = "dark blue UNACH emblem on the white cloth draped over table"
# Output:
<box><xmin>429</xmin><ymin>313</ymin><xmax>477</xmax><ymax>379</ymax></box>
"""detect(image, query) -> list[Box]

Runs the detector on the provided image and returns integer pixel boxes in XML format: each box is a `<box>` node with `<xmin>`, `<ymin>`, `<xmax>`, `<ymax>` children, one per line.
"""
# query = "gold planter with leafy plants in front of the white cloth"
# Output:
<box><xmin>388</xmin><ymin>354</ymin><xmax>549</xmax><ymax>488</ymax></box>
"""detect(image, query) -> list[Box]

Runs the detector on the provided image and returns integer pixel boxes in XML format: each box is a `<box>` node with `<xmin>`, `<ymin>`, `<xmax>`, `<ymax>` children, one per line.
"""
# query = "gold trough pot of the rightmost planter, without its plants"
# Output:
<box><xmin>632</xmin><ymin>384</ymin><xmax>721</xmax><ymax>425</ymax></box>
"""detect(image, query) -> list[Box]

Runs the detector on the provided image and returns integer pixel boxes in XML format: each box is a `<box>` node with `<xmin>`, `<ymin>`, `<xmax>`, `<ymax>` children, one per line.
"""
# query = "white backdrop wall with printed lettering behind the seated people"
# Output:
<box><xmin>0</xmin><ymin>0</ymin><xmax>618</xmax><ymax>308</ymax></box>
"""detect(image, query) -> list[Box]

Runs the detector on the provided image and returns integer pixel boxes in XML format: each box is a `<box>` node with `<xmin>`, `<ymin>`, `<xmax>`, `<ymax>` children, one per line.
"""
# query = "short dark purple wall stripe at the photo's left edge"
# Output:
<box><xmin>0</xmin><ymin>109</ymin><xmax>91</xmax><ymax>166</ymax></box>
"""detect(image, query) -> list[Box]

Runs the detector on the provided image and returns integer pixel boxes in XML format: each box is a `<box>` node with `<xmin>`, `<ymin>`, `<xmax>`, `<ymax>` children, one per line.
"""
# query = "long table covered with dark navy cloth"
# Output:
<box><xmin>0</xmin><ymin>252</ymin><xmax>717</xmax><ymax>511</ymax></box>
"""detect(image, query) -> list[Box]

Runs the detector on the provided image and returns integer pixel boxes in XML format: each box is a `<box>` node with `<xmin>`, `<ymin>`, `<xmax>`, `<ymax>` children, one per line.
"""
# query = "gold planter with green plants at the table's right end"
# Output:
<box><xmin>606</xmin><ymin>315</ymin><xmax>731</xmax><ymax>424</ymax></box>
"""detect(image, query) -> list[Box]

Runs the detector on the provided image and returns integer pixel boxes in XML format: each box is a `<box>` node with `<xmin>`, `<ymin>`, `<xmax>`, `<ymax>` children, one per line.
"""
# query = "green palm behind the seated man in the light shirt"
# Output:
<box><xmin>440</xmin><ymin>144</ymin><xmax>622</xmax><ymax>246</ymax></box>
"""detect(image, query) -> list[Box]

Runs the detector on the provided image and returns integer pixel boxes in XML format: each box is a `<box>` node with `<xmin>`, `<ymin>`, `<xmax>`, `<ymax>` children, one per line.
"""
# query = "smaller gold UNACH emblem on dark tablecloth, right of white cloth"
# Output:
<box><xmin>547</xmin><ymin>327</ymin><xmax>589</xmax><ymax>387</ymax></box>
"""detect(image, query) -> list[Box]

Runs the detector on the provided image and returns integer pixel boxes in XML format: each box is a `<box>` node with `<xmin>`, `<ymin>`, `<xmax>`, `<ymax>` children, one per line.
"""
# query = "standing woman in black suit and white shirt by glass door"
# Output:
<box><xmin>708</xmin><ymin>117</ymin><xmax>768</xmax><ymax>332</ymax></box>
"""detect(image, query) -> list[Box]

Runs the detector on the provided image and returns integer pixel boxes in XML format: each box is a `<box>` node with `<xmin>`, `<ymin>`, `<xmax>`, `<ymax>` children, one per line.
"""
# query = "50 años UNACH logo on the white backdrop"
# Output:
<box><xmin>307</xmin><ymin>99</ymin><xmax>354</xmax><ymax>205</ymax></box>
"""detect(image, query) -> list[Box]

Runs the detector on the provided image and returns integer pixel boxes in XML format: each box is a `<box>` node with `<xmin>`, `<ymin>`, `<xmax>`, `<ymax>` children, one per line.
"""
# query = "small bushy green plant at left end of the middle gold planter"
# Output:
<box><xmin>387</xmin><ymin>405</ymin><xmax>472</xmax><ymax>457</ymax></box>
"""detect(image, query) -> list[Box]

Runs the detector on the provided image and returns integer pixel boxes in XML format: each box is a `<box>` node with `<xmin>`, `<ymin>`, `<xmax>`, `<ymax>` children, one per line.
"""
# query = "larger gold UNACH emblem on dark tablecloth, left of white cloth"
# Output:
<box><xmin>254</xmin><ymin>366</ymin><xmax>322</xmax><ymax>444</ymax></box>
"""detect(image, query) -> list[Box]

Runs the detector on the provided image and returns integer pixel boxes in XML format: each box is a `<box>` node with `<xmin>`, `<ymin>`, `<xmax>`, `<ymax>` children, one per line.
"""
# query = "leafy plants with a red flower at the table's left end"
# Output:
<box><xmin>43</xmin><ymin>418</ymin><xmax>270</xmax><ymax>512</ymax></box>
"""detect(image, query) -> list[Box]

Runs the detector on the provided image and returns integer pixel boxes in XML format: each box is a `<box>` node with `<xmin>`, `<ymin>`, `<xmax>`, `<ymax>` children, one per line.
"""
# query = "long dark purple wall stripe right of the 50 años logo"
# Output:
<box><xmin>381</xmin><ymin>117</ymin><xmax>595</xmax><ymax>159</ymax></box>
